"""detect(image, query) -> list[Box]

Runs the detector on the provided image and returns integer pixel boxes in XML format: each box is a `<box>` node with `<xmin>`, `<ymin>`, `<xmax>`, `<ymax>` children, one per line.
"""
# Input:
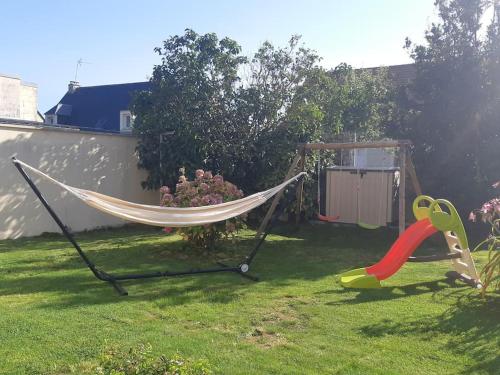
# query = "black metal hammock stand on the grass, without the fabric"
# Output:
<box><xmin>12</xmin><ymin>157</ymin><xmax>304</xmax><ymax>296</ymax></box>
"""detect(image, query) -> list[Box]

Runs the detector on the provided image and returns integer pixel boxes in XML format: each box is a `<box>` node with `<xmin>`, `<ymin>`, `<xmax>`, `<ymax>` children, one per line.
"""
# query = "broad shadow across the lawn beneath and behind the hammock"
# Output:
<box><xmin>0</xmin><ymin>226</ymin><xmax>376</xmax><ymax>309</ymax></box>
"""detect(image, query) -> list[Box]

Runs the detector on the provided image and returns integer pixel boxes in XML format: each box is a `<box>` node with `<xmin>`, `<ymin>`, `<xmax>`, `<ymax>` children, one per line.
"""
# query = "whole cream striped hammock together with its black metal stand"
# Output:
<box><xmin>12</xmin><ymin>157</ymin><xmax>305</xmax><ymax>295</ymax></box>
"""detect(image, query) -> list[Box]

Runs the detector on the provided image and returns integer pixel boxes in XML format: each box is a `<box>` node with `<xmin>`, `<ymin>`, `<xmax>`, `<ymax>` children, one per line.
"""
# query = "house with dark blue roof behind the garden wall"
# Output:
<box><xmin>45</xmin><ymin>81</ymin><xmax>150</xmax><ymax>133</ymax></box>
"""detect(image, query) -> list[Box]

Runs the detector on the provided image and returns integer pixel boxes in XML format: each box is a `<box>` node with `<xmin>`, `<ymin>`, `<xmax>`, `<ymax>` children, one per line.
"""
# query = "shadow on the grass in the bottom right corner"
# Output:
<box><xmin>361</xmin><ymin>295</ymin><xmax>500</xmax><ymax>374</ymax></box>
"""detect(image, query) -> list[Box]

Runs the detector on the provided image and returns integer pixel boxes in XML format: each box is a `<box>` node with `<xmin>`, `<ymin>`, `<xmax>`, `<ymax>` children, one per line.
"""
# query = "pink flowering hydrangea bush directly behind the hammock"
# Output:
<box><xmin>160</xmin><ymin>168</ymin><xmax>243</xmax><ymax>249</ymax></box>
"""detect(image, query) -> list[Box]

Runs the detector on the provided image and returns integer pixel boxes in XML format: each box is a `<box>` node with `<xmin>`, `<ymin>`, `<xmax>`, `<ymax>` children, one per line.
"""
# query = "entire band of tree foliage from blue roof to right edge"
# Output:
<box><xmin>133</xmin><ymin>0</ymin><xmax>500</xmax><ymax>223</ymax></box>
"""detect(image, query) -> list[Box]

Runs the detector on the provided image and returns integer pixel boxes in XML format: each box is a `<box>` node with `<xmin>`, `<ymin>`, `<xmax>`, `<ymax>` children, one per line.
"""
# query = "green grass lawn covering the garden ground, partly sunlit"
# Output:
<box><xmin>0</xmin><ymin>225</ymin><xmax>500</xmax><ymax>374</ymax></box>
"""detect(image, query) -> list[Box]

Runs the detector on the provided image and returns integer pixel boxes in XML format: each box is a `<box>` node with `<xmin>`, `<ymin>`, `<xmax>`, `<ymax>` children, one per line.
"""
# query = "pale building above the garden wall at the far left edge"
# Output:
<box><xmin>0</xmin><ymin>74</ymin><xmax>43</xmax><ymax>122</ymax></box>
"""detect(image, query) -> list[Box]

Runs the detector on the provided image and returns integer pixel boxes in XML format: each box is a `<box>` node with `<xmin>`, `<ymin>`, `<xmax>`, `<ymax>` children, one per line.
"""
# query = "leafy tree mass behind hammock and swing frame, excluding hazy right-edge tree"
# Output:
<box><xmin>133</xmin><ymin>30</ymin><xmax>392</xmax><ymax>216</ymax></box>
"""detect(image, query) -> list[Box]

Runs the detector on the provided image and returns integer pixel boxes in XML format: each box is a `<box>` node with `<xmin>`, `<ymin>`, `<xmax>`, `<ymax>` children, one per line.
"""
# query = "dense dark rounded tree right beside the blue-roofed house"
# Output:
<box><xmin>132</xmin><ymin>29</ymin><xmax>246</xmax><ymax>188</ymax></box>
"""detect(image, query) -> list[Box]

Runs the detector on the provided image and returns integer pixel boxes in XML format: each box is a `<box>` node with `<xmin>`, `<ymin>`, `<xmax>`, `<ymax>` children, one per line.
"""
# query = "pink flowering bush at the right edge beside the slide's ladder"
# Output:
<box><xmin>469</xmin><ymin>181</ymin><xmax>500</xmax><ymax>295</ymax></box>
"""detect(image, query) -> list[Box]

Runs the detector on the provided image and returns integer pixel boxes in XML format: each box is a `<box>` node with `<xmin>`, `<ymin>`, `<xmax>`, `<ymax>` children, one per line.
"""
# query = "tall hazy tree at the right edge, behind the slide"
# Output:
<box><xmin>396</xmin><ymin>0</ymin><xmax>500</xmax><ymax>216</ymax></box>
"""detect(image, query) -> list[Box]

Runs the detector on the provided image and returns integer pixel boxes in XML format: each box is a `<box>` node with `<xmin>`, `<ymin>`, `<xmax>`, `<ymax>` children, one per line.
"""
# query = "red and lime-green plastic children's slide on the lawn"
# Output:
<box><xmin>340</xmin><ymin>196</ymin><xmax>480</xmax><ymax>288</ymax></box>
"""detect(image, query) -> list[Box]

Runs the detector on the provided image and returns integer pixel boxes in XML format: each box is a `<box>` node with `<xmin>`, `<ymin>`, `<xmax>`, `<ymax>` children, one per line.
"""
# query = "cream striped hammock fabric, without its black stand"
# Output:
<box><xmin>16</xmin><ymin>160</ymin><xmax>305</xmax><ymax>227</ymax></box>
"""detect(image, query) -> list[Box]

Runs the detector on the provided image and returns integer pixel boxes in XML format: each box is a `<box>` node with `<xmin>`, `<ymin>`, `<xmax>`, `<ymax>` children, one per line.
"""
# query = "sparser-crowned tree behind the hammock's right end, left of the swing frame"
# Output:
<box><xmin>231</xmin><ymin>36</ymin><xmax>321</xmax><ymax>192</ymax></box>
